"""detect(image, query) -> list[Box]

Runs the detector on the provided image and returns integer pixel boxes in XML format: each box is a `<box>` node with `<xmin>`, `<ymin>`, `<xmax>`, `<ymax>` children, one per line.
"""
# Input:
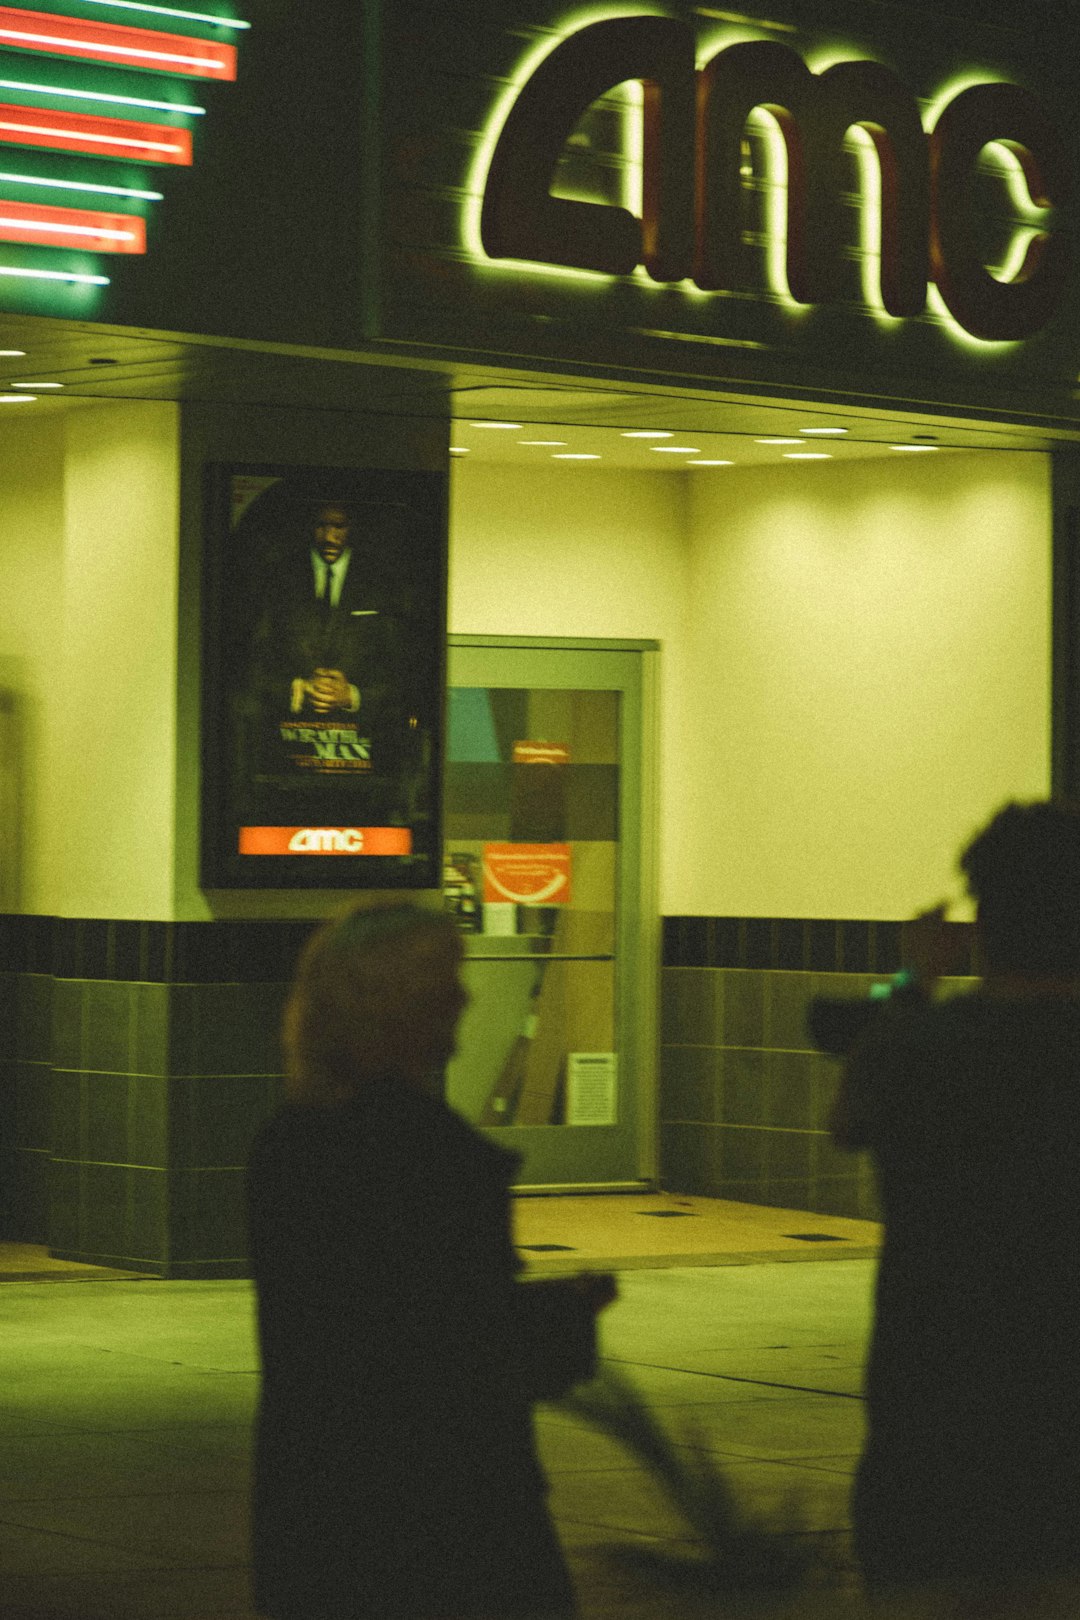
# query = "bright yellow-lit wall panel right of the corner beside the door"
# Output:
<box><xmin>689</xmin><ymin>454</ymin><xmax>1051</xmax><ymax>917</ymax></box>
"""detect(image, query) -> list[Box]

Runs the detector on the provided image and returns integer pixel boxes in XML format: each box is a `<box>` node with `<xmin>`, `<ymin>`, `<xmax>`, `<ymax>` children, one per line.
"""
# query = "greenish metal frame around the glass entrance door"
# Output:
<box><xmin>447</xmin><ymin>632</ymin><xmax>661</xmax><ymax>1194</ymax></box>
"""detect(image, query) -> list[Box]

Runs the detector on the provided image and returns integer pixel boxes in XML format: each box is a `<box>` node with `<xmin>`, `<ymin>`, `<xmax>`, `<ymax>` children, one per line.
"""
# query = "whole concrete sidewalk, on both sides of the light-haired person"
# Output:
<box><xmin>0</xmin><ymin>1260</ymin><xmax>873</xmax><ymax>1620</ymax></box>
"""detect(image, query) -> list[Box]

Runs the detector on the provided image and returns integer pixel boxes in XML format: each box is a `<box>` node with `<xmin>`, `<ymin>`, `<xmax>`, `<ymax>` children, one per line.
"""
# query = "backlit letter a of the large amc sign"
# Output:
<box><xmin>479</xmin><ymin>16</ymin><xmax>695</xmax><ymax>282</ymax></box>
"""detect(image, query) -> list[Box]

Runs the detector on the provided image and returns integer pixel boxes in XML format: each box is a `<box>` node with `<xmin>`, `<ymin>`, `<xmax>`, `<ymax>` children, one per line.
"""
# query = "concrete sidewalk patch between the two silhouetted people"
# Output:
<box><xmin>553</xmin><ymin>1260</ymin><xmax>874</xmax><ymax>1620</ymax></box>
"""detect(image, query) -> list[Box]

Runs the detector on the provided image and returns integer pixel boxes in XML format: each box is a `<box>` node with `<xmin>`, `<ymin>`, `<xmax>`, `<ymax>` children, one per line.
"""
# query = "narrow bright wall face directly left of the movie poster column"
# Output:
<box><xmin>55</xmin><ymin>402</ymin><xmax>180</xmax><ymax>919</ymax></box>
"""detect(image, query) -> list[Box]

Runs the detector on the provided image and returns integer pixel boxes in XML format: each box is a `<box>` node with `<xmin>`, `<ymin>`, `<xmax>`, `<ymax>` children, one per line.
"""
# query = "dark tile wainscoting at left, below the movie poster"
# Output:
<box><xmin>0</xmin><ymin>915</ymin><xmax>311</xmax><ymax>1277</ymax></box>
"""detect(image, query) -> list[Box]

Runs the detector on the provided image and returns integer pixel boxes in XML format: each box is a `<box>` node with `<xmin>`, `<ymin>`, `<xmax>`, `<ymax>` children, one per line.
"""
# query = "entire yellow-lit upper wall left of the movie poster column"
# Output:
<box><xmin>0</xmin><ymin>402</ymin><xmax>178</xmax><ymax>919</ymax></box>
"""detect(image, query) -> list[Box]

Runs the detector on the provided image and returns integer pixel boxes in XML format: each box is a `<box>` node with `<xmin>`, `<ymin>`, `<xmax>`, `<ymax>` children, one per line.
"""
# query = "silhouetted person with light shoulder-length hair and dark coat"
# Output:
<box><xmin>249</xmin><ymin>904</ymin><xmax>614</xmax><ymax>1620</ymax></box>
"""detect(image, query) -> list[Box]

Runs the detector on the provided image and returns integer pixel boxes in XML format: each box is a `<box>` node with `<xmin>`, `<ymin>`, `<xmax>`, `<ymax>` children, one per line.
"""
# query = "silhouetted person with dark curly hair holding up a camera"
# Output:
<box><xmin>832</xmin><ymin>804</ymin><xmax>1080</xmax><ymax>1615</ymax></box>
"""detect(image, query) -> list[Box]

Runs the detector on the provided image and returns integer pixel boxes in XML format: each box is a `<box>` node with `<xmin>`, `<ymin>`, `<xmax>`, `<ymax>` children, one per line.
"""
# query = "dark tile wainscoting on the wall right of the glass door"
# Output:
<box><xmin>661</xmin><ymin>917</ymin><xmax>973</xmax><ymax>1220</ymax></box>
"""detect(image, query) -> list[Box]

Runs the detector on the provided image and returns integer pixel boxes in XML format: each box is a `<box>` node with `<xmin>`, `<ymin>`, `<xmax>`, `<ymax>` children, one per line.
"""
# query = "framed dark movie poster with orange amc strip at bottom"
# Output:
<box><xmin>202</xmin><ymin>467</ymin><xmax>447</xmax><ymax>888</ymax></box>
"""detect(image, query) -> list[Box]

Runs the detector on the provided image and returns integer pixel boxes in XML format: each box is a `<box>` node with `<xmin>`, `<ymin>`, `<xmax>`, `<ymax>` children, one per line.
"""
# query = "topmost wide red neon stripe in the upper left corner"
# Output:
<box><xmin>0</xmin><ymin>5</ymin><xmax>236</xmax><ymax>79</ymax></box>
